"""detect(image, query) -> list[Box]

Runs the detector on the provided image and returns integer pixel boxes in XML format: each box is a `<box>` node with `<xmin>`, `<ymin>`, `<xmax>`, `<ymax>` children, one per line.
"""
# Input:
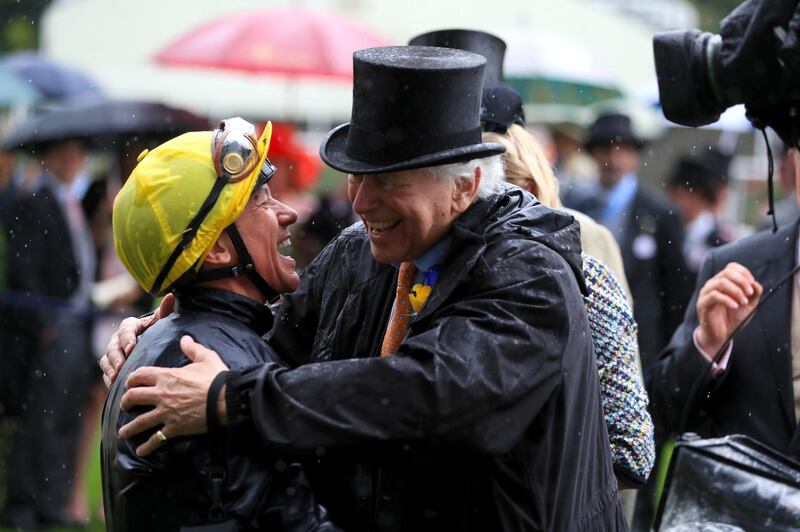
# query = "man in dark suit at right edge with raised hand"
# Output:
<box><xmin>647</xmin><ymin>150</ymin><xmax>800</xmax><ymax>458</ymax></box>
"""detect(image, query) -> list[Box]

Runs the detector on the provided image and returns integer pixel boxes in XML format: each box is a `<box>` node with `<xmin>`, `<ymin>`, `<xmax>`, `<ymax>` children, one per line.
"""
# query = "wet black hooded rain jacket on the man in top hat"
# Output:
<box><xmin>226</xmin><ymin>187</ymin><xmax>626</xmax><ymax>531</ymax></box>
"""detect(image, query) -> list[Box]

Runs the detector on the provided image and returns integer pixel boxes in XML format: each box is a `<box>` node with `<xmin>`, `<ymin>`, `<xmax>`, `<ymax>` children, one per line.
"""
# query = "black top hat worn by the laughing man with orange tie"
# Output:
<box><xmin>319</xmin><ymin>46</ymin><xmax>505</xmax><ymax>174</ymax></box>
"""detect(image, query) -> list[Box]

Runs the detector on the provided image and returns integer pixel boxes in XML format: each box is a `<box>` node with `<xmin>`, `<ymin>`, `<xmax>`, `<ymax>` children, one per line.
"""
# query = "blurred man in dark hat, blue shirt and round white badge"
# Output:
<box><xmin>567</xmin><ymin>113</ymin><xmax>689</xmax><ymax>369</ymax></box>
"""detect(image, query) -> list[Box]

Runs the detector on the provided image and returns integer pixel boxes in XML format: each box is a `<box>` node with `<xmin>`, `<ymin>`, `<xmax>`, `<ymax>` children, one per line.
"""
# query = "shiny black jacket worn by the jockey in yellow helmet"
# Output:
<box><xmin>101</xmin><ymin>289</ymin><xmax>330</xmax><ymax>532</ymax></box>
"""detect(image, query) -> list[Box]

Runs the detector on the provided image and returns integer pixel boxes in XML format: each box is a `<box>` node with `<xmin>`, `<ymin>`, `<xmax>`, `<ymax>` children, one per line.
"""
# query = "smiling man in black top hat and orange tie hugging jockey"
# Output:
<box><xmin>103</xmin><ymin>46</ymin><xmax>626</xmax><ymax>531</ymax></box>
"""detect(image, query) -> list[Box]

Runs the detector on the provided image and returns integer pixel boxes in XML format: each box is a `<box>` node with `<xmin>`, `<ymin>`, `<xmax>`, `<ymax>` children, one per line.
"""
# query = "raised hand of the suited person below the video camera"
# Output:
<box><xmin>696</xmin><ymin>262</ymin><xmax>763</xmax><ymax>355</ymax></box>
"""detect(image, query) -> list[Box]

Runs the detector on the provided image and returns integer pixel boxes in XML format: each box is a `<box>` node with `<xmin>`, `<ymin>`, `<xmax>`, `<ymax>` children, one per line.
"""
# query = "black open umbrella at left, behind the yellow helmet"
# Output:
<box><xmin>0</xmin><ymin>100</ymin><xmax>209</xmax><ymax>149</ymax></box>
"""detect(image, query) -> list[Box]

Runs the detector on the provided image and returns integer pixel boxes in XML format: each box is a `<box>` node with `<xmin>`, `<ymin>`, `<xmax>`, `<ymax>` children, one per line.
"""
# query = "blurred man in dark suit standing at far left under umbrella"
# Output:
<box><xmin>1</xmin><ymin>140</ymin><xmax>95</xmax><ymax>530</ymax></box>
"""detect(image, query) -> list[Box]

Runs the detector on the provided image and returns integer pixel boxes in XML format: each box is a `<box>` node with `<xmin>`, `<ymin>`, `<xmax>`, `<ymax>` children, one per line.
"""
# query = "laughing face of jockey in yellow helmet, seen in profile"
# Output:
<box><xmin>234</xmin><ymin>185</ymin><xmax>300</xmax><ymax>299</ymax></box>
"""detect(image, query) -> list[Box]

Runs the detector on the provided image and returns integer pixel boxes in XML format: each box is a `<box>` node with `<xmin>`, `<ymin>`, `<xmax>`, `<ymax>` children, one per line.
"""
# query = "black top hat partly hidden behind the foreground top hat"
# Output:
<box><xmin>408</xmin><ymin>30</ymin><xmax>506</xmax><ymax>87</ymax></box>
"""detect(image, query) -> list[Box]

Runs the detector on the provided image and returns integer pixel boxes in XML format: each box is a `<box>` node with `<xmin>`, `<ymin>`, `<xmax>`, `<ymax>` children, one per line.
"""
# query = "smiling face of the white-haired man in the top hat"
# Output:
<box><xmin>347</xmin><ymin>170</ymin><xmax>466</xmax><ymax>264</ymax></box>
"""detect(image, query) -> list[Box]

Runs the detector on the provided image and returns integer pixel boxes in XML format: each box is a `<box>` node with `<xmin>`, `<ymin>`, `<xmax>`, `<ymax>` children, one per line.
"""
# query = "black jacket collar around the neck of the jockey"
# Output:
<box><xmin>176</xmin><ymin>287</ymin><xmax>273</xmax><ymax>336</ymax></box>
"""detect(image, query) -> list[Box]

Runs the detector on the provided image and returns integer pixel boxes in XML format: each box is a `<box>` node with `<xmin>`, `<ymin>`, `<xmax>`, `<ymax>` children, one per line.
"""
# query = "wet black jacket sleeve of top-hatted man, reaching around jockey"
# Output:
<box><xmin>226</xmin><ymin>239</ymin><xmax>587</xmax><ymax>453</ymax></box>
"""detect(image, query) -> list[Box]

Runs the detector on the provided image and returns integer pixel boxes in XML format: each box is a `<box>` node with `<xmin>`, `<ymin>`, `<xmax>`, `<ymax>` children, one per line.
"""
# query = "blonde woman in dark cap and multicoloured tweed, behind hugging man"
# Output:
<box><xmin>481</xmin><ymin>86</ymin><xmax>655</xmax><ymax>488</ymax></box>
